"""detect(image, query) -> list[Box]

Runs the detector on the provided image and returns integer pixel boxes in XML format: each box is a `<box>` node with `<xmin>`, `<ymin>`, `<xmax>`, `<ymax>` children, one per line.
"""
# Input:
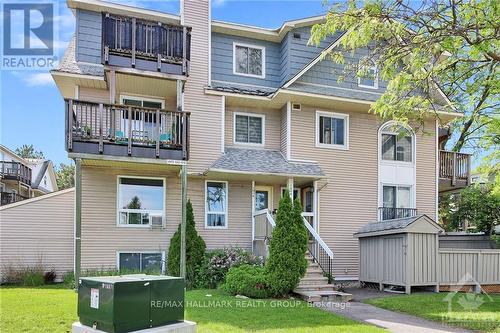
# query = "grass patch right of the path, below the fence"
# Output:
<box><xmin>366</xmin><ymin>293</ymin><xmax>500</xmax><ymax>332</ymax></box>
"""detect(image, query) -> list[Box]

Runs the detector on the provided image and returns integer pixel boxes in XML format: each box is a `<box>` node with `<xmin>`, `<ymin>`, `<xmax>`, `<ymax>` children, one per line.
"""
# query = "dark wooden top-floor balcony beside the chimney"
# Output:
<box><xmin>102</xmin><ymin>14</ymin><xmax>191</xmax><ymax>75</ymax></box>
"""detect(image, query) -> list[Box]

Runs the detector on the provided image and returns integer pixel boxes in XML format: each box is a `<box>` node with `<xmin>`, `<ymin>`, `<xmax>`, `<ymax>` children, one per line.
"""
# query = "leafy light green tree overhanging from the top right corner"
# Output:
<box><xmin>310</xmin><ymin>0</ymin><xmax>500</xmax><ymax>158</ymax></box>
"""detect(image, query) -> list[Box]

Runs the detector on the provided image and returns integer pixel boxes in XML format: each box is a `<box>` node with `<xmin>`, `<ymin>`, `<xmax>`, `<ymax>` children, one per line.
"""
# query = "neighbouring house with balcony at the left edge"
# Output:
<box><xmin>0</xmin><ymin>145</ymin><xmax>57</xmax><ymax>206</ymax></box>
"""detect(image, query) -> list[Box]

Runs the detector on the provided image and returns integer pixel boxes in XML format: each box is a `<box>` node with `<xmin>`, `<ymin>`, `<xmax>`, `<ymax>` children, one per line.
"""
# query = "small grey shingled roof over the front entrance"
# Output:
<box><xmin>210</xmin><ymin>148</ymin><xmax>325</xmax><ymax>177</ymax></box>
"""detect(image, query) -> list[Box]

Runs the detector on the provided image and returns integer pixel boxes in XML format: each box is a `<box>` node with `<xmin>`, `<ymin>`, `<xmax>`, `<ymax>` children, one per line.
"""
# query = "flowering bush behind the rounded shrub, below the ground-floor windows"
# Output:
<box><xmin>196</xmin><ymin>248</ymin><xmax>263</xmax><ymax>289</ymax></box>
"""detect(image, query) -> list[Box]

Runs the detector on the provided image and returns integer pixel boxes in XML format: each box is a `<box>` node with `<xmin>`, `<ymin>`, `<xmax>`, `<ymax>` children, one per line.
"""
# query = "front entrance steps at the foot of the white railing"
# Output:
<box><xmin>294</xmin><ymin>252</ymin><xmax>352</xmax><ymax>303</ymax></box>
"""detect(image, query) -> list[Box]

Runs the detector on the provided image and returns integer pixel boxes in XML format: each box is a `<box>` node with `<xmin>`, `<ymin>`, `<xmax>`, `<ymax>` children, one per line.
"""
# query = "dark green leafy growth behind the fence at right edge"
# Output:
<box><xmin>444</xmin><ymin>184</ymin><xmax>500</xmax><ymax>235</ymax></box>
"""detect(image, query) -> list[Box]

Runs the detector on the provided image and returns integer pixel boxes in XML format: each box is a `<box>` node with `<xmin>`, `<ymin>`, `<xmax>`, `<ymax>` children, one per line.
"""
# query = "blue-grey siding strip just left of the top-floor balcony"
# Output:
<box><xmin>76</xmin><ymin>9</ymin><xmax>102</xmax><ymax>64</ymax></box>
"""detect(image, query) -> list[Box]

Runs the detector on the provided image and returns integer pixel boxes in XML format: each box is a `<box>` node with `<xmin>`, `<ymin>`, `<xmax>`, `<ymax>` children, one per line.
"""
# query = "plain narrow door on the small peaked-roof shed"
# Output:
<box><xmin>383</xmin><ymin>236</ymin><xmax>406</xmax><ymax>284</ymax></box>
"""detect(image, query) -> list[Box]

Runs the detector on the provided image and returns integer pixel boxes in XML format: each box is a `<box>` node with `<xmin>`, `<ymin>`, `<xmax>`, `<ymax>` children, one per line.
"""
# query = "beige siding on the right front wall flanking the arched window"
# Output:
<box><xmin>291</xmin><ymin>105</ymin><xmax>436</xmax><ymax>277</ymax></box>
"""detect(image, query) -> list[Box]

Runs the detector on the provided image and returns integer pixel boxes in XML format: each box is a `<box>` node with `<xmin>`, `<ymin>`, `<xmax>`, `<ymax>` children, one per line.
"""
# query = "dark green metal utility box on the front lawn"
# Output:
<box><xmin>78</xmin><ymin>274</ymin><xmax>184</xmax><ymax>333</ymax></box>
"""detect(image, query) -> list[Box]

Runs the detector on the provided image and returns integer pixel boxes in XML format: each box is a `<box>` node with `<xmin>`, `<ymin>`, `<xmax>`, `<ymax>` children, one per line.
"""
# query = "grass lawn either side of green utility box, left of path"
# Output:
<box><xmin>0</xmin><ymin>287</ymin><xmax>384</xmax><ymax>333</ymax></box>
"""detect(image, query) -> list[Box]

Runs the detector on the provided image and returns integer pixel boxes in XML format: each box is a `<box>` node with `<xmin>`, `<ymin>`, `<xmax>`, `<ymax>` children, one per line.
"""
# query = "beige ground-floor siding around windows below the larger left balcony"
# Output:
<box><xmin>82</xmin><ymin>165</ymin><xmax>252</xmax><ymax>270</ymax></box>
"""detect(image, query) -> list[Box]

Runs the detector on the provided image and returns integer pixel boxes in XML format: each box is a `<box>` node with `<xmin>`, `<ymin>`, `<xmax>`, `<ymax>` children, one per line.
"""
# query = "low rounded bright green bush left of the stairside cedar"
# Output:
<box><xmin>222</xmin><ymin>265</ymin><xmax>270</xmax><ymax>298</ymax></box>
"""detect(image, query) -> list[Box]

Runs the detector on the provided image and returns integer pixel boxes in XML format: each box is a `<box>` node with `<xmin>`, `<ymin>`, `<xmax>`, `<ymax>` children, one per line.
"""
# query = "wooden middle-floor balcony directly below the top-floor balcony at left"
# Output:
<box><xmin>65</xmin><ymin>99</ymin><xmax>190</xmax><ymax>160</ymax></box>
